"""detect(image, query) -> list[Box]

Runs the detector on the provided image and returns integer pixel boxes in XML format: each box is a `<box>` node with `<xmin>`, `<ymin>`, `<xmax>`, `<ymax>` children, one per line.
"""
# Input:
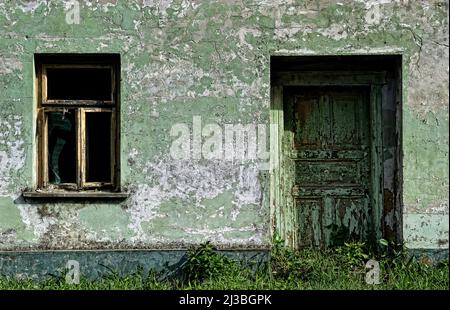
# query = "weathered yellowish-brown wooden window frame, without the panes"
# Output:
<box><xmin>37</xmin><ymin>58</ymin><xmax>120</xmax><ymax>192</ymax></box>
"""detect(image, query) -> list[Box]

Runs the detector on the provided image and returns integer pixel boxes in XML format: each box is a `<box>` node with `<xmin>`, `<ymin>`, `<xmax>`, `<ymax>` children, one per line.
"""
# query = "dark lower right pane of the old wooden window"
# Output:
<box><xmin>86</xmin><ymin>112</ymin><xmax>111</xmax><ymax>182</ymax></box>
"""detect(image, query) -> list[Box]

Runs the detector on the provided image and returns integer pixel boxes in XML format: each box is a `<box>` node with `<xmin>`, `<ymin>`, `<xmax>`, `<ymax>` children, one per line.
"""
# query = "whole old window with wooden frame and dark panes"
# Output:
<box><xmin>37</xmin><ymin>56</ymin><xmax>118</xmax><ymax>190</ymax></box>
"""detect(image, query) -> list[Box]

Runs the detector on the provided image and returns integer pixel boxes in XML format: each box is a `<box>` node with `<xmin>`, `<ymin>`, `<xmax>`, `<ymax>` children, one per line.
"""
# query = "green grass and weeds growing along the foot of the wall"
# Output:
<box><xmin>0</xmin><ymin>242</ymin><xmax>449</xmax><ymax>290</ymax></box>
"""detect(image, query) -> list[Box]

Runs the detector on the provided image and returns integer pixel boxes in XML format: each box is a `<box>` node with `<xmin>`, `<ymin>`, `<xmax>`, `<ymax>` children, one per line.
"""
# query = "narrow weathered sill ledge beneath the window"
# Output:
<box><xmin>22</xmin><ymin>191</ymin><xmax>129</xmax><ymax>200</ymax></box>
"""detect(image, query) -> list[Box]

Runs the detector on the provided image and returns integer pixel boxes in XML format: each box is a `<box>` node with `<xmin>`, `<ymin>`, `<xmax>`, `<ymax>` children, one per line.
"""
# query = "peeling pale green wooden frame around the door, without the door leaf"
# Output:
<box><xmin>270</xmin><ymin>71</ymin><xmax>386</xmax><ymax>248</ymax></box>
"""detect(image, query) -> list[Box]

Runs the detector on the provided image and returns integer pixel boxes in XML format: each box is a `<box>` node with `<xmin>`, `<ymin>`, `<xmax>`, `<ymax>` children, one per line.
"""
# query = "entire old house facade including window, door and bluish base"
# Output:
<box><xmin>0</xmin><ymin>0</ymin><xmax>449</xmax><ymax>275</ymax></box>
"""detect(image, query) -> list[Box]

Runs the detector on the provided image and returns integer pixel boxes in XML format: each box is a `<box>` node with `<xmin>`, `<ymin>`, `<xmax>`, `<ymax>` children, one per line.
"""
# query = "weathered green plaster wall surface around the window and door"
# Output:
<box><xmin>0</xmin><ymin>0</ymin><xmax>449</xmax><ymax>250</ymax></box>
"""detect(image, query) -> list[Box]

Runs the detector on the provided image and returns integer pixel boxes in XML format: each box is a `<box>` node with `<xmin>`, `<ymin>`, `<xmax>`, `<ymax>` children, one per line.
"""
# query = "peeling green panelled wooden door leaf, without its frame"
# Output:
<box><xmin>283</xmin><ymin>86</ymin><xmax>374</xmax><ymax>247</ymax></box>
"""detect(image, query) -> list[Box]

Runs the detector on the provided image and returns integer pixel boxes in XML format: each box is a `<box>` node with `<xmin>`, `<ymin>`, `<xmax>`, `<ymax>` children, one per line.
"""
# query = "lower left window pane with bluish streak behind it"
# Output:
<box><xmin>47</xmin><ymin>110</ymin><xmax>76</xmax><ymax>184</ymax></box>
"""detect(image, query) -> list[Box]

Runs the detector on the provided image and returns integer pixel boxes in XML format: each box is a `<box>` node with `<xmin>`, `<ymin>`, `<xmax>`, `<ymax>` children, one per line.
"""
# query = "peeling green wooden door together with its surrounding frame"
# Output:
<box><xmin>272</xmin><ymin>71</ymin><xmax>384</xmax><ymax>248</ymax></box>
